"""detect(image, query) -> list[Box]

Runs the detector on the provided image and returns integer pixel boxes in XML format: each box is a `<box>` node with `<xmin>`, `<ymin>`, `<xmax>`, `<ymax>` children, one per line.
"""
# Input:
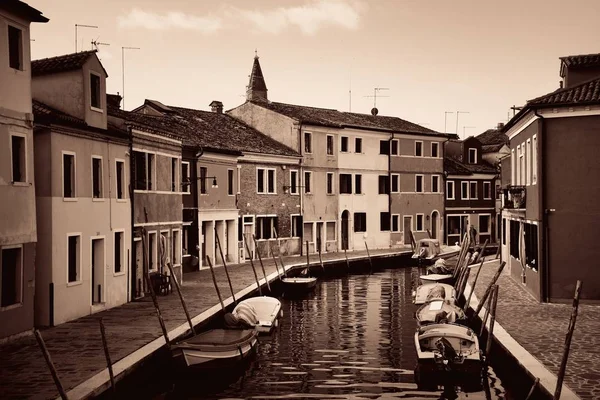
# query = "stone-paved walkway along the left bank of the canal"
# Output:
<box><xmin>0</xmin><ymin>249</ymin><xmax>408</xmax><ymax>399</ymax></box>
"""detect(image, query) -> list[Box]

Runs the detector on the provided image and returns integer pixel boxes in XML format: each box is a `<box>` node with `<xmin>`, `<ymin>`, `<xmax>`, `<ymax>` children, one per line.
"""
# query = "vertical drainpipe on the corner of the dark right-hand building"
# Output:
<box><xmin>533</xmin><ymin>109</ymin><xmax>550</xmax><ymax>302</ymax></box>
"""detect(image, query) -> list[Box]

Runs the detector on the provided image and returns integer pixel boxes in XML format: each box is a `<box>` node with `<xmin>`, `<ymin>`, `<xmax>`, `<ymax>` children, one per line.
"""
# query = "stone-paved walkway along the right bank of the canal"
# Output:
<box><xmin>469</xmin><ymin>261</ymin><xmax>600</xmax><ymax>399</ymax></box>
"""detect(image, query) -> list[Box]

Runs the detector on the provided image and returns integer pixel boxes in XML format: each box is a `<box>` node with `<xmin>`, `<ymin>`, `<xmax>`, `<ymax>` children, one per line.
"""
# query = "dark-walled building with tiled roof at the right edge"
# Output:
<box><xmin>502</xmin><ymin>54</ymin><xmax>600</xmax><ymax>301</ymax></box>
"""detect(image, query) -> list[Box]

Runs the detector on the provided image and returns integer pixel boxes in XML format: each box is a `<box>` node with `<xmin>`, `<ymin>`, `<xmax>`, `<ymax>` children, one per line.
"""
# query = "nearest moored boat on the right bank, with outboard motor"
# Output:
<box><xmin>415</xmin><ymin>324</ymin><xmax>482</xmax><ymax>391</ymax></box>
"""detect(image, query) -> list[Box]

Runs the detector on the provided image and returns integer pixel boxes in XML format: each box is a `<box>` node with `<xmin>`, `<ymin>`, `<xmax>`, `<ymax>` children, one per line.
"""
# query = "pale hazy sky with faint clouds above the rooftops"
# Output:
<box><xmin>26</xmin><ymin>0</ymin><xmax>600</xmax><ymax>136</ymax></box>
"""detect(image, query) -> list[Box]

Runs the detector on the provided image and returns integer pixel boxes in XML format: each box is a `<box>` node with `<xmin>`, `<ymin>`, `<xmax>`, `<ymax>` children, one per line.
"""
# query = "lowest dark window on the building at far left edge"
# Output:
<box><xmin>0</xmin><ymin>246</ymin><xmax>23</xmax><ymax>308</ymax></box>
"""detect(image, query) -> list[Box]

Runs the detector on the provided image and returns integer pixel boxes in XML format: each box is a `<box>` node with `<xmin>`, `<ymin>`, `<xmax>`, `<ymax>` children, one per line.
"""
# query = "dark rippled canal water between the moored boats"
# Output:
<box><xmin>119</xmin><ymin>268</ymin><xmax>522</xmax><ymax>400</ymax></box>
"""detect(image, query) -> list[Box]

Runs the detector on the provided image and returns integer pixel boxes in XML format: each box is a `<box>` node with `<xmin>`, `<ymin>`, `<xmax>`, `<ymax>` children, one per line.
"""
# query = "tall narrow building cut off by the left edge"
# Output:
<box><xmin>0</xmin><ymin>0</ymin><xmax>48</xmax><ymax>341</ymax></box>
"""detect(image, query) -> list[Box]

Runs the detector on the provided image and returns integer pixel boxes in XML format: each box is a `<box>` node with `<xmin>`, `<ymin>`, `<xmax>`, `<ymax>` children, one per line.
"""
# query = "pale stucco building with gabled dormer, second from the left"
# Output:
<box><xmin>32</xmin><ymin>51</ymin><xmax>131</xmax><ymax>326</ymax></box>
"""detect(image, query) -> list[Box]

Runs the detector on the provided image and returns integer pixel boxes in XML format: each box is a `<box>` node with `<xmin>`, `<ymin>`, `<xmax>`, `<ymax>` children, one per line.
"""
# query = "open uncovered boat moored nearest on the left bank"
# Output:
<box><xmin>171</xmin><ymin>329</ymin><xmax>258</xmax><ymax>369</ymax></box>
